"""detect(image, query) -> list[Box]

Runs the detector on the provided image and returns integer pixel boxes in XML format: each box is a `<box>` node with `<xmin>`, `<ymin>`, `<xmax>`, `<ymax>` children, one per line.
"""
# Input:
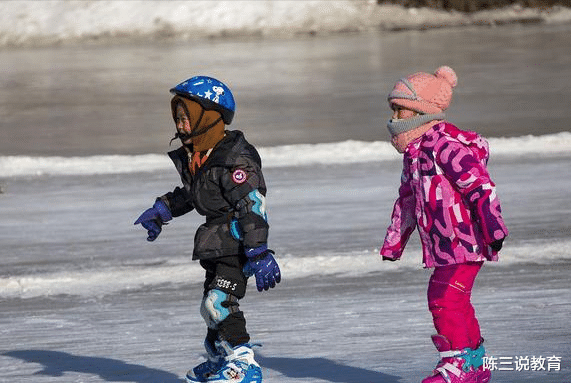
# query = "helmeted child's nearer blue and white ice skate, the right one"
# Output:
<box><xmin>206</xmin><ymin>344</ymin><xmax>262</xmax><ymax>383</ymax></box>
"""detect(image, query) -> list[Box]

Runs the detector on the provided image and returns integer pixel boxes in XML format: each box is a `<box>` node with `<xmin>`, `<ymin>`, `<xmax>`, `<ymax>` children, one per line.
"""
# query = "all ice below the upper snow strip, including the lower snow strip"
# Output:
<box><xmin>0</xmin><ymin>157</ymin><xmax>571</xmax><ymax>383</ymax></box>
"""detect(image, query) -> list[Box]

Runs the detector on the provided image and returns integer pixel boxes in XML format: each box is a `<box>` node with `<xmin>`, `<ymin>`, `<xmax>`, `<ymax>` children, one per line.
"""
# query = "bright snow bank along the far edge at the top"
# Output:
<box><xmin>0</xmin><ymin>0</ymin><xmax>571</xmax><ymax>47</ymax></box>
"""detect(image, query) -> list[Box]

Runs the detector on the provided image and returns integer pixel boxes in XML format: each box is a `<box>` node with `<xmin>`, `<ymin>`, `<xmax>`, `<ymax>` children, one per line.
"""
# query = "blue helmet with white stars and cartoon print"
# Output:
<box><xmin>170</xmin><ymin>76</ymin><xmax>236</xmax><ymax>125</ymax></box>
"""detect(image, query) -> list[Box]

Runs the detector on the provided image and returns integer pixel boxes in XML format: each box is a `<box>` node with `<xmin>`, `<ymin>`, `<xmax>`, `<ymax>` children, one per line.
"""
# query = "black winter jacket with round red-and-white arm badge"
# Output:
<box><xmin>159</xmin><ymin>130</ymin><xmax>268</xmax><ymax>259</ymax></box>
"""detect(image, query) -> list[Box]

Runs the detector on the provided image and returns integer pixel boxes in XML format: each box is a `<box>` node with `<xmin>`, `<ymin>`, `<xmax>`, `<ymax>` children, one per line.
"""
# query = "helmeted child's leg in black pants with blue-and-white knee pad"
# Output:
<box><xmin>200</xmin><ymin>256</ymin><xmax>250</xmax><ymax>347</ymax></box>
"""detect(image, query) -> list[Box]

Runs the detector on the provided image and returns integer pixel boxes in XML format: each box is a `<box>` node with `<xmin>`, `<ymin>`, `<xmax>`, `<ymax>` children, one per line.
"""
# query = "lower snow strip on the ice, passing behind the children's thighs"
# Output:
<box><xmin>0</xmin><ymin>237</ymin><xmax>571</xmax><ymax>298</ymax></box>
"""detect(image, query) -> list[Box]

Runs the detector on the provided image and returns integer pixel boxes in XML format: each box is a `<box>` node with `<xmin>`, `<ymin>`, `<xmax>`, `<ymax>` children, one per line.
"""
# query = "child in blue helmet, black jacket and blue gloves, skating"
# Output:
<box><xmin>135</xmin><ymin>76</ymin><xmax>281</xmax><ymax>383</ymax></box>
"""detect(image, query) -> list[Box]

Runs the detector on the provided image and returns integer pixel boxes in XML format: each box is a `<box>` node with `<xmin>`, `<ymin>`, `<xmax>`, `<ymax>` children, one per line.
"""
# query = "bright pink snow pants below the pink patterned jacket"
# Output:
<box><xmin>428</xmin><ymin>262</ymin><xmax>483</xmax><ymax>350</ymax></box>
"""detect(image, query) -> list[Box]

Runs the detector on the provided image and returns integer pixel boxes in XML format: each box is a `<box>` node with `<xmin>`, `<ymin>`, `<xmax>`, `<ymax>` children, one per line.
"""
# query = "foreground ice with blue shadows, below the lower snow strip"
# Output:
<box><xmin>0</xmin><ymin>261</ymin><xmax>571</xmax><ymax>383</ymax></box>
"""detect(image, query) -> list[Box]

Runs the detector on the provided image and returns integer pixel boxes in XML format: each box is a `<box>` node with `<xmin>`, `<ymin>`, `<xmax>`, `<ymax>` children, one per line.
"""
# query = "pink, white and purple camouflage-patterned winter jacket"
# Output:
<box><xmin>380</xmin><ymin>122</ymin><xmax>508</xmax><ymax>267</ymax></box>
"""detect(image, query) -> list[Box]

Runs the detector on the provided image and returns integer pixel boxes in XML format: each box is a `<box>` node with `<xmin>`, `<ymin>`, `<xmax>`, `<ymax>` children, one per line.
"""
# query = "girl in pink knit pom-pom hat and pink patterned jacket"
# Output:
<box><xmin>380</xmin><ymin>66</ymin><xmax>508</xmax><ymax>383</ymax></box>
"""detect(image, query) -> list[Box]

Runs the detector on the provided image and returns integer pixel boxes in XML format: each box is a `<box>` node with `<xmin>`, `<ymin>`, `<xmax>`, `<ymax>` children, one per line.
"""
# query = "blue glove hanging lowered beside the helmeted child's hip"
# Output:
<box><xmin>243</xmin><ymin>245</ymin><xmax>282</xmax><ymax>291</ymax></box>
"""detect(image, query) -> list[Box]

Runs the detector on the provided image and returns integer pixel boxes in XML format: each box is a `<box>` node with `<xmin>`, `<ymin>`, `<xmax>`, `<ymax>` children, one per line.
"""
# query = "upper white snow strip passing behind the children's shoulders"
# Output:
<box><xmin>0</xmin><ymin>132</ymin><xmax>571</xmax><ymax>177</ymax></box>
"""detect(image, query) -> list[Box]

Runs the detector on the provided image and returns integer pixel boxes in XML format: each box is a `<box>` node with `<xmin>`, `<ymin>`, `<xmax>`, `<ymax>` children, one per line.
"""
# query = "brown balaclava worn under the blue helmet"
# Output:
<box><xmin>171</xmin><ymin>96</ymin><xmax>225</xmax><ymax>152</ymax></box>
